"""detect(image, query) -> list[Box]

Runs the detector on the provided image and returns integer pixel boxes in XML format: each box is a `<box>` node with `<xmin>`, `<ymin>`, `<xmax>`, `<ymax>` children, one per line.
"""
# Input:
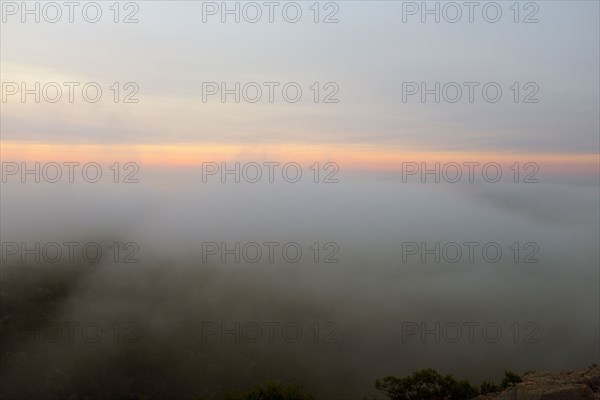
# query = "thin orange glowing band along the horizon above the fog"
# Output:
<box><xmin>0</xmin><ymin>142</ymin><xmax>599</xmax><ymax>175</ymax></box>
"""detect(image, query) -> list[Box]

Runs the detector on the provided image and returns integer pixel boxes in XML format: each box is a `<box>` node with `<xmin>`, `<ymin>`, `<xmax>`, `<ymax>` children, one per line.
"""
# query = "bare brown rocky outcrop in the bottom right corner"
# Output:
<box><xmin>475</xmin><ymin>367</ymin><xmax>600</xmax><ymax>400</ymax></box>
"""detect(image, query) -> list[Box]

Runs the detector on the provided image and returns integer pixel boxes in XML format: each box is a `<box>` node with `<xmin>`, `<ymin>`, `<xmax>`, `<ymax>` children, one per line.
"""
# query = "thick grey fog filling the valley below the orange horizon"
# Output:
<box><xmin>1</xmin><ymin>170</ymin><xmax>600</xmax><ymax>399</ymax></box>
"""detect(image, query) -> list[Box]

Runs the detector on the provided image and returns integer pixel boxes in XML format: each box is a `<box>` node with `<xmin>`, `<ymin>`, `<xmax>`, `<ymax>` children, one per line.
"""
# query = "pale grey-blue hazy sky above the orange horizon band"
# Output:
<box><xmin>1</xmin><ymin>1</ymin><xmax>600</xmax><ymax>162</ymax></box>
